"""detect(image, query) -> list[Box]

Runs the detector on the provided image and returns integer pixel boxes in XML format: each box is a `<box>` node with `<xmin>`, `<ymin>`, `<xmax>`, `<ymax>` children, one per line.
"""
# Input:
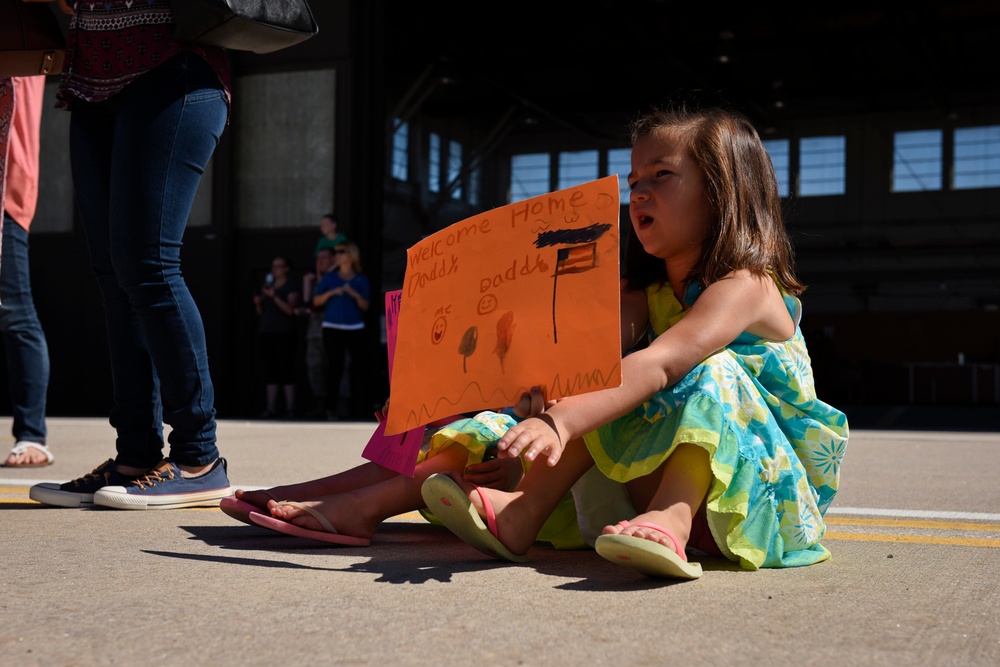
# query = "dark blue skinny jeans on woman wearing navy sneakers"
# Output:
<box><xmin>70</xmin><ymin>53</ymin><xmax>229</xmax><ymax>467</ymax></box>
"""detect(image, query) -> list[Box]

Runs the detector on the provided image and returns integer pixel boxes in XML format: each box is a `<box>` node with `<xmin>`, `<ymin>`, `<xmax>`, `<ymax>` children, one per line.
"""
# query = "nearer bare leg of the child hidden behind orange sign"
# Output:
<box><xmin>267</xmin><ymin>446</ymin><xmax>469</xmax><ymax>538</ymax></box>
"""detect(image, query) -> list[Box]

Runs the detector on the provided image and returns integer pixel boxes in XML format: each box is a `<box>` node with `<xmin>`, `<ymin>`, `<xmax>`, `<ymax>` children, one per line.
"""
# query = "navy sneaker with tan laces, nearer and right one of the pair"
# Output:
<box><xmin>94</xmin><ymin>458</ymin><xmax>233</xmax><ymax>510</ymax></box>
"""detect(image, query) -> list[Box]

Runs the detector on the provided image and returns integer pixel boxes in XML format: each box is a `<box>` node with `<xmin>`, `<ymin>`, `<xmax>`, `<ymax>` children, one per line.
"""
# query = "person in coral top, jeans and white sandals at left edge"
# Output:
<box><xmin>0</xmin><ymin>76</ymin><xmax>54</xmax><ymax>468</ymax></box>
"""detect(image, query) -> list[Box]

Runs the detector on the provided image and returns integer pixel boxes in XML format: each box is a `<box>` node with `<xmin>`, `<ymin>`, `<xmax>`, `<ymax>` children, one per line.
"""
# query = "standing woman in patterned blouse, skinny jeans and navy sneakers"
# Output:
<box><xmin>30</xmin><ymin>0</ymin><xmax>231</xmax><ymax>509</ymax></box>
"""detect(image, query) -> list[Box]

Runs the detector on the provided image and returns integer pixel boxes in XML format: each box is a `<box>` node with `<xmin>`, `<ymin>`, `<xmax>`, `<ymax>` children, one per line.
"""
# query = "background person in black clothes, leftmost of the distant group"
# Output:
<box><xmin>253</xmin><ymin>255</ymin><xmax>302</xmax><ymax>419</ymax></box>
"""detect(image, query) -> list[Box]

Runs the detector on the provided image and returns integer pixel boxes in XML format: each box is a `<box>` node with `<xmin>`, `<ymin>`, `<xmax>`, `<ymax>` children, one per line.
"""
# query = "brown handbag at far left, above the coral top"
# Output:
<box><xmin>0</xmin><ymin>0</ymin><xmax>66</xmax><ymax>76</ymax></box>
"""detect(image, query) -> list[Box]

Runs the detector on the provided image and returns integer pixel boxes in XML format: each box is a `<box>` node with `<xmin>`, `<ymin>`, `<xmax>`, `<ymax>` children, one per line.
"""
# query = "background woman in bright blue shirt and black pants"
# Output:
<box><xmin>313</xmin><ymin>241</ymin><xmax>370</xmax><ymax>419</ymax></box>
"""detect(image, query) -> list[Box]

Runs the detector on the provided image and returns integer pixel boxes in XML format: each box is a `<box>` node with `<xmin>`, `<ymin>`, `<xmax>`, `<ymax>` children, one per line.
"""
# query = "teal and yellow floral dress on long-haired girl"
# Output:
<box><xmin>584</xmin><ymin>285</ymin><xmax>848</xmax><ymax>570</ymax></box>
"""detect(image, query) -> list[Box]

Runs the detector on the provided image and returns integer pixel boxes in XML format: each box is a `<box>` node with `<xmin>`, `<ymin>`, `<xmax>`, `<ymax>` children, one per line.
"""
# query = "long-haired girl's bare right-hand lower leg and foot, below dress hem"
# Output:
<box><xmin>602</xmin><ymin>444</ymin><xmax>712</xmax><ymax>550</ymax></box>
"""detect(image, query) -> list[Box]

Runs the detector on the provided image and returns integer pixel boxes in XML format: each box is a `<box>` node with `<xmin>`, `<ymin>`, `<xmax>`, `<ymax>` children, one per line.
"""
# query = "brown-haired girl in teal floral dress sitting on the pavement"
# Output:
<box><xmin>423</xmin><ymin>96</ymin><xmax>848</xmax><ymax>578</ymax></box>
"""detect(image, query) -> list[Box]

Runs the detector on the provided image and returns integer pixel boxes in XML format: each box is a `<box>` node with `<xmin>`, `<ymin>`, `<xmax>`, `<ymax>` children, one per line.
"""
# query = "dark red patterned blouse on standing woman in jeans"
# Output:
<box><xmin>56</xmin><ymin>0</ymin><xmax>230</xmax><ymax>109</ymax></box>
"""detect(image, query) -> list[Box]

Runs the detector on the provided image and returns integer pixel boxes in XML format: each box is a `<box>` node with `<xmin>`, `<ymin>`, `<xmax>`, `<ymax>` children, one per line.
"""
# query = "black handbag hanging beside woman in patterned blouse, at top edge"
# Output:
<box><xmin>170</xmin><ymin>0</ymin><xmax>319</xmax><ymax>53</ymax></box>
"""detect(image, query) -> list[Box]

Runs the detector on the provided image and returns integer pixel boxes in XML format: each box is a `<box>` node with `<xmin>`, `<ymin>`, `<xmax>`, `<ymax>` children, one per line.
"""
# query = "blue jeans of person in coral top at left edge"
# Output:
<box><xmin>0</xmin><ymin>213</ymin><xmax>49</xmax><ymax>444</ymax></box>
